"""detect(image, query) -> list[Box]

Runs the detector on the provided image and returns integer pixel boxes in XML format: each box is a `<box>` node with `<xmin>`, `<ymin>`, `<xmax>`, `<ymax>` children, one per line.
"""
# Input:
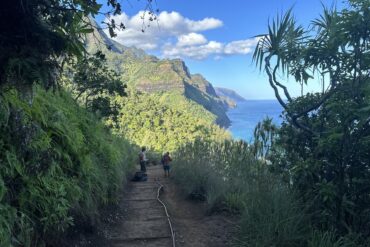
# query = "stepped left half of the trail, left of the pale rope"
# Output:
<box><xmin>108</xmin><ymin>166</ymin><xmax>172</xmax><ymax>247</ymax></box>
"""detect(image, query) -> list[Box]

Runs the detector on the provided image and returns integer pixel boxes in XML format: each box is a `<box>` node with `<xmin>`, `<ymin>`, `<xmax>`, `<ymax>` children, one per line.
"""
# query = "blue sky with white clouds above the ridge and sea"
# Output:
<box><xmin>97</xmin><ymin>0</ymin><xmax>343</xmax><ymax>99</ymax></box>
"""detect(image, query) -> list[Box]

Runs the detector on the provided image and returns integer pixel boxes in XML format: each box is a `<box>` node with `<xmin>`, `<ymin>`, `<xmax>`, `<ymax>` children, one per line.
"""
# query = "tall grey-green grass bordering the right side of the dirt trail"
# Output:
<box><xmin>174</xmin><ymin>140</ymin><xmax>309</xmax><ymax>247</ymax></box>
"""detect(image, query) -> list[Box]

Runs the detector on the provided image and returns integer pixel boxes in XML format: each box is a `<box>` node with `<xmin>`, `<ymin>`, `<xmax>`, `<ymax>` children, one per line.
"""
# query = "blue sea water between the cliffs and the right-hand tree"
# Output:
<box><xmin>227</xmin><ymin>100</ymin><xmax>283</xmax><ymax>142</ymax></box>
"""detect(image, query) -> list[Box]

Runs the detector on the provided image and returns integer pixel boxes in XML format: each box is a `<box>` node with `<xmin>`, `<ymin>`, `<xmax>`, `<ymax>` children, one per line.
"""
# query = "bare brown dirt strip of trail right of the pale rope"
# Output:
<box><xmin>161</xmin><ymin>170</ymin><xmax>235</xmax><ymax>247</ymax></box>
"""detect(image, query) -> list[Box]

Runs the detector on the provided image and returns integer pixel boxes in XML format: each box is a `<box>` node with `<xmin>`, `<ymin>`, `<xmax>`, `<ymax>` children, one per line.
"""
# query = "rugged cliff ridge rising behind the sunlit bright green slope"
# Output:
<box><xmin>86</xmin><ymin>23</ymin><xmax>230</xmax><ymax>127</ymax></box>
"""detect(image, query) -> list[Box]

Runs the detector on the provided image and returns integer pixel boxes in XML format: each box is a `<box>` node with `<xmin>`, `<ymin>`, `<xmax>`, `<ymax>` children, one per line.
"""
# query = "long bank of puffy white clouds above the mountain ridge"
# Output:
<box><xmin>102</xmin><ymin>11</ymin><xmax>257</xmax><ymax>60</ymax></box>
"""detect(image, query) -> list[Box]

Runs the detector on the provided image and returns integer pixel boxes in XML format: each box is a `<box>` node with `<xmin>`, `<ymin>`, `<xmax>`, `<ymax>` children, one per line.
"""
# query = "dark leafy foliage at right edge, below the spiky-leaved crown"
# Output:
<box><xmin>275</xmin><ymin>82</ymin><xmax>370</xmax><ymax>237</ymax></box>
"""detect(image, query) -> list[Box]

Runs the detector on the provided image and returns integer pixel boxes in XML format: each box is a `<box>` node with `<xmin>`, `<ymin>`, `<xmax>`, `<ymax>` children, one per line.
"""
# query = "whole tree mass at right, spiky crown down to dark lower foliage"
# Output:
<box><xmin>253</xmin><ymin>0</ymin><xmax>370</xmax><ymax>236</ymax></box>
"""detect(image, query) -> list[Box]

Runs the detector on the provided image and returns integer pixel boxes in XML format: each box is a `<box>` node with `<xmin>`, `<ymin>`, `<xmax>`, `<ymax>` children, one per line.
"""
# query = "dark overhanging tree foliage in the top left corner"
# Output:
<box><xmin>0</xmin><ymin>0</ymin><xmax>156</xmax><ymax>97</ymax></box>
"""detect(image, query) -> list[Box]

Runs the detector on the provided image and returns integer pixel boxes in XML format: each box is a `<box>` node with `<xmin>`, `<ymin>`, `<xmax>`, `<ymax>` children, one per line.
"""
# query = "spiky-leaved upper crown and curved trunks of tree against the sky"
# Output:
<box><xmin>253</xmin><ymin>0</ymin><xmax>370</xmax><ymax>134</ymax></box>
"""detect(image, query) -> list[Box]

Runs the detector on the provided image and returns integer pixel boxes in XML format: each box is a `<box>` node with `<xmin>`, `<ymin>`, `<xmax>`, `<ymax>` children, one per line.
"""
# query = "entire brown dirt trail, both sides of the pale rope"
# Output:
<box><xmin>76</xmin><ymin>166</ymin><xmax>234</xmax><ymax>247</ymax></box>
